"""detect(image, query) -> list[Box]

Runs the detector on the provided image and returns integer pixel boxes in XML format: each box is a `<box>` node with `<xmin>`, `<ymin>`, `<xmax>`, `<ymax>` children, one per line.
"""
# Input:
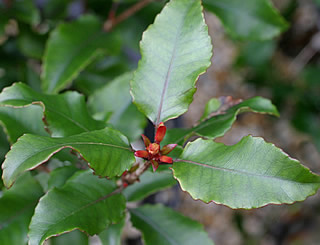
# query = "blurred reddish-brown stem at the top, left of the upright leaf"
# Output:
<box><xmin>103</xmin><ymin>0</ymin><xmax>153</xmax><ymax>32</ymax></box>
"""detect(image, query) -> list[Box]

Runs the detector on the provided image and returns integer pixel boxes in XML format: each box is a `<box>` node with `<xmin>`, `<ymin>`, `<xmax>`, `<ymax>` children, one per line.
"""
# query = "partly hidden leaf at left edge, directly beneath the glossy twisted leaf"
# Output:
<box><xmin>0</xmin><ymin>105</ymin><xmax>48</xmax><ymax>143</ymax></box>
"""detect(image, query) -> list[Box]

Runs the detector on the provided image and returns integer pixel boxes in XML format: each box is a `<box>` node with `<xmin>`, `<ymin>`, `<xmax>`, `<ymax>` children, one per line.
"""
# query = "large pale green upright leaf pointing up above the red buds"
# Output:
<box><xmin>131</xmin><ymin>0</ymin><xmax>212</xmax><ymax>125</ymax></box>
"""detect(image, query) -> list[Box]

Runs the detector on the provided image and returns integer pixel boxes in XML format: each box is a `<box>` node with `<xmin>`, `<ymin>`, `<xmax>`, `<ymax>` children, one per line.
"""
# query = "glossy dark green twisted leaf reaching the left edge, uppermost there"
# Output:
<box><xmin>0</xmin><ymin>83</ymin><xmax>106</xmax><ymax>137</ymax></box>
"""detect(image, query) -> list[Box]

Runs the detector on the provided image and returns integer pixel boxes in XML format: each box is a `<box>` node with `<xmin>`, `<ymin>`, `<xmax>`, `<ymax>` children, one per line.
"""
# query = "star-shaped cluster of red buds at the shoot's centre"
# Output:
<box><xmin>134</xmin><ymin>122</ymin><xmax>177</xmax><ymax>171</ymax></box>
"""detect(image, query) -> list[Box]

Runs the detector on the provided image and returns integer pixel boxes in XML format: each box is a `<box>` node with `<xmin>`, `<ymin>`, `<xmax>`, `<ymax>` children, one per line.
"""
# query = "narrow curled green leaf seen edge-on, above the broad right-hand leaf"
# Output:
<box><xmin>168</xmin><ymin>96</ymin><xmax>279</xmax><ymax>145</ymax></box>
